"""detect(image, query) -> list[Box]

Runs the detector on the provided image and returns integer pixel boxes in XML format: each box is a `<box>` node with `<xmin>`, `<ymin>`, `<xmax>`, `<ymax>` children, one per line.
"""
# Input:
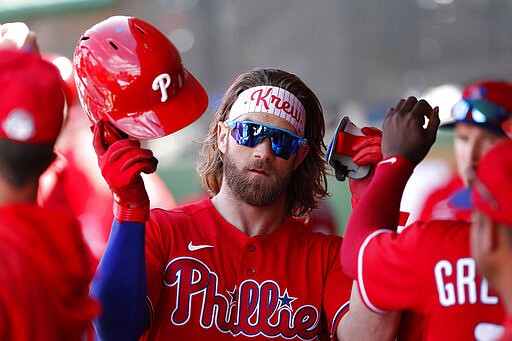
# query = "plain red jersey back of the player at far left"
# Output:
<box><xmin>0</xmin><ymin>204</ymin><xmax>99</xmax><ymax>341</ymax></box>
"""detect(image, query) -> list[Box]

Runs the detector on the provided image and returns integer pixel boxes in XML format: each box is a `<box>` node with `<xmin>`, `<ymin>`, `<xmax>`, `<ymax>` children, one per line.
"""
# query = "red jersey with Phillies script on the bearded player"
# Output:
<box><xmin>143</xmin><ymin>199</ymin><xmax>352</xmax><ymax>341</ymax></box>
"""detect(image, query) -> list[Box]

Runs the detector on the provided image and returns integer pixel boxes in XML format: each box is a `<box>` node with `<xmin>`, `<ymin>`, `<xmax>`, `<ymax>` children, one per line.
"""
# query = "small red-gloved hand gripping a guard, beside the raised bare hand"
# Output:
<box><xmin>352</xmin><ymin>127</ymin><xmax>382</xmax><ymax>166</ymax></box>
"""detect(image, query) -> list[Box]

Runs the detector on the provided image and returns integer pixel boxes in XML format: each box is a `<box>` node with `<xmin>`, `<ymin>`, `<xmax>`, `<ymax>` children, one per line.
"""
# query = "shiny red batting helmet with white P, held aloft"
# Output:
<box><xmin>74</xmin><ymin>16</ymin><xmax>208</xmax><ymax>140</ymax></box>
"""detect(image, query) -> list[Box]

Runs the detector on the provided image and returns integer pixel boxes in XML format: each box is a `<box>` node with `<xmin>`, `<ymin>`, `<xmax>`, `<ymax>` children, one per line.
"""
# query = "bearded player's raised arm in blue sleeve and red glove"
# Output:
<box><xmin>91</xmin><ymin>122</ymin><xmax>156</xmax><ymax>340</ymax></box>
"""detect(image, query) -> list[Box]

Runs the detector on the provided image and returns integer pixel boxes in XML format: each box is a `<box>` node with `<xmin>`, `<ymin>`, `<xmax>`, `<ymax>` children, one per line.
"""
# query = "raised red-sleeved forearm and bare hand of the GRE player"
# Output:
<box><xmin>341</xmin><ymin>97</ymin><xmax>439</xmax><ymax>279</ymax></box>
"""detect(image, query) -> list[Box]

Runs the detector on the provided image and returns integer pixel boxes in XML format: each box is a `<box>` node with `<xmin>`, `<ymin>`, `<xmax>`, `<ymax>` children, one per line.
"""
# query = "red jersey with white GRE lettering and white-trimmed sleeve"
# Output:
<box><xmin>357</xmin><ymin>220</ymin><xmax>505</xmax><ymax>340</ymax></box>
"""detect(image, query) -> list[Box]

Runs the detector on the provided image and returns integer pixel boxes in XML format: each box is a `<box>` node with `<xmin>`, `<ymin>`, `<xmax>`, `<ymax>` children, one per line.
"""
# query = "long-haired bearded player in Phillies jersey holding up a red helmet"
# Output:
<box><xmin>74</xmin><ymin>17</ymin><xmax>396</xmax><ymax>340</ymax></box>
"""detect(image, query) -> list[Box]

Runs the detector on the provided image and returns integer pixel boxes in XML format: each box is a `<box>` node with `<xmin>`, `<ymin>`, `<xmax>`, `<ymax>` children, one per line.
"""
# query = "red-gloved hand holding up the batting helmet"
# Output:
<box><xmin>93</xmin><ymin>121</ymin><xmax>156</xmax><ymax>223</ymax></box>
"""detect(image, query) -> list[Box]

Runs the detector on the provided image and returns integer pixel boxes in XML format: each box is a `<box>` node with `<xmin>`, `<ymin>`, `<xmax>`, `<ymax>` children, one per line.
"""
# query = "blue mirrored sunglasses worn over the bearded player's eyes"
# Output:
<box><xmin>224</xmin><ymin>121</ymin><xmax>308</xmax><ymax>160</ymax></box>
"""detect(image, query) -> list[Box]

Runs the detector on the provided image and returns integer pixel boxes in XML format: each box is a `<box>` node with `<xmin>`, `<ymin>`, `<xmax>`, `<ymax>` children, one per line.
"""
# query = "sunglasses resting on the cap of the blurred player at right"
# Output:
<box><xmin>452</xmin><ymin>99</ymin><xmax>508</xmax><ymax>124</ymax></box>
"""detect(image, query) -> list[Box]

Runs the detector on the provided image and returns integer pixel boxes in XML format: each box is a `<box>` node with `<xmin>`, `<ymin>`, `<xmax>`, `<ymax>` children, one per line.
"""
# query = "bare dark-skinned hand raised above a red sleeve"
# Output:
<box><xmin>382</xmin><ymin>97</ymin><xmax>440</xmax><ymax>166</ymax></box>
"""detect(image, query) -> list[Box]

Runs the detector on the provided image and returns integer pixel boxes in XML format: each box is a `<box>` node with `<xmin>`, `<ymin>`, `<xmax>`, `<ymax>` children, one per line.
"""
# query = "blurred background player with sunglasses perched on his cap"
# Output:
<box><xmin>418</xmin><ymin>80</ymin><xmax>512</xmax><ymax>221</ymax></box>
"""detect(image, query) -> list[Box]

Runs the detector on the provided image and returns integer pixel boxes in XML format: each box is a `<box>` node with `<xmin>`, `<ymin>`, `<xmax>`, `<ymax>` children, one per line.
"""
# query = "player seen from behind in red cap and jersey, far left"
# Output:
<box><xmin>0</xmin><ymin>23</ymin><xmax>98</xmax><ymax>341</ymax></box>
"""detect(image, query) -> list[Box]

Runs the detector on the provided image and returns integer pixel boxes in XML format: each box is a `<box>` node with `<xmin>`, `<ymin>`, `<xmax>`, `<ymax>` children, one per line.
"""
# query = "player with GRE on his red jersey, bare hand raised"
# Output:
<box><xmin>341</xmin><ymin>97</ymin><xmax>504</xmax><ymax>340</ymax></box>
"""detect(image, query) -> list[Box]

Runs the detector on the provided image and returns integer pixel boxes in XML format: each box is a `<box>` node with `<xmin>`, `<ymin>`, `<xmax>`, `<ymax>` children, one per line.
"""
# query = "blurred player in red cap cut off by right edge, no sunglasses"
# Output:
<box><xmin>469</xmin><ymin>140</ymin><xmax>512</xmax><ymax>341</ymax></box>
